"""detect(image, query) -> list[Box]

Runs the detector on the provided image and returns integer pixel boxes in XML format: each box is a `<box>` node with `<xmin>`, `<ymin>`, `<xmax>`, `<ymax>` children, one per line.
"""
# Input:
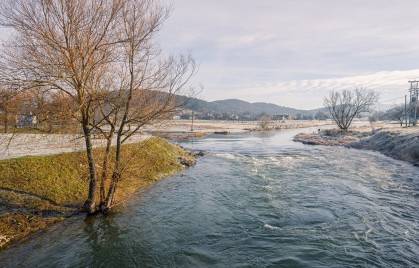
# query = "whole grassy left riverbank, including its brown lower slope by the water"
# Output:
<box><xmin>0</xmin><ymin>138</ymin><xmax>194</xmax><ymax>248</ymax></box>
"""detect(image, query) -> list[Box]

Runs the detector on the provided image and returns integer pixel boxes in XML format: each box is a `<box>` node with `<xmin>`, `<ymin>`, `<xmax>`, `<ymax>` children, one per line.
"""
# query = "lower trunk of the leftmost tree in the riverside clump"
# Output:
<box><xmin>83</xmin><ymin>120</ymin><xmax>97</xmax><ymax>214</ymax></box>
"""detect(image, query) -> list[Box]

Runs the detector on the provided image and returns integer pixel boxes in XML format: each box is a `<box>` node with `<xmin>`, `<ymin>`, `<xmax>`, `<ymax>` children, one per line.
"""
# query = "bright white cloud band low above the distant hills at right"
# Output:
<box><xmin>209</xmin><ymin>69</ymin><xmax>419</xmax><ymax>109</ymax></box>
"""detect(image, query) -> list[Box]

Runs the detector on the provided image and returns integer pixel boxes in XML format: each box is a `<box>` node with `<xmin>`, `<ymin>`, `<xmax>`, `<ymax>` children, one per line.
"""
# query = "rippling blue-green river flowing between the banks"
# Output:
<box><xmin>0</xmin><ymin>130</ymin><xmax>419</xmax><ymax>267</ymax></box>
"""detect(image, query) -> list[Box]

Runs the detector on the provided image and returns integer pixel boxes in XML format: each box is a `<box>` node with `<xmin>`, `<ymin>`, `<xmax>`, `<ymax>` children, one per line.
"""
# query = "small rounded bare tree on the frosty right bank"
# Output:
<box><xmin>324</xmin><ymin>88</ymin><xmax>378</xmax><ymax>131</ymax></box>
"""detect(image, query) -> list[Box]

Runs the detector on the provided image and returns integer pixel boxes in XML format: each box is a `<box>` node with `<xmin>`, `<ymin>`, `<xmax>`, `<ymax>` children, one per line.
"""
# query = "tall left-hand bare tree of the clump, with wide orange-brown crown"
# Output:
<box><xmin>0</xmin><ymin>0</ymin><xmax>124</xmax><ymax>212</ymax></box>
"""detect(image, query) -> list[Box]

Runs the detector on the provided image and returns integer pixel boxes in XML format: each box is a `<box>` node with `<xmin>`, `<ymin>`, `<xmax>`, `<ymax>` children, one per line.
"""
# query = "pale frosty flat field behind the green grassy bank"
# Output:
<box><xmin>0</xmin><ymin>120</ymin><xmax>332</xmax><ymax>159</ymax></box>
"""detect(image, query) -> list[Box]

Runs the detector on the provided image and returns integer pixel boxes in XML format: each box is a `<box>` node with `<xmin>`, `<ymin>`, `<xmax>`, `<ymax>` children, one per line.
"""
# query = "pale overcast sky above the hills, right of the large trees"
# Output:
<box><xmin>160</xmin><ymin>0</ymin><xmax>419</xmax><ymax>108</ymax></box>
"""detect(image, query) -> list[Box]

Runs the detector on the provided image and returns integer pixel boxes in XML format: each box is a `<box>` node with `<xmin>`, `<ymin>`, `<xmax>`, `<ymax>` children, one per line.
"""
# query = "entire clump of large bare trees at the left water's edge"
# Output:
<box><xmin>0</xmin><ymin>0</ymin><xmax>195</xmax><ymax>213</ymax></box>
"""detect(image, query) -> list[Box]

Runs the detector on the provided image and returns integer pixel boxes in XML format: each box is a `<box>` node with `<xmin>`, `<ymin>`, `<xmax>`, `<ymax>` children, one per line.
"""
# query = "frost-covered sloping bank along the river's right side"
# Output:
<box><xmin>294</xmin><ymin>129</ymin><xmax>419</xmax><ymax>165</ymax></box>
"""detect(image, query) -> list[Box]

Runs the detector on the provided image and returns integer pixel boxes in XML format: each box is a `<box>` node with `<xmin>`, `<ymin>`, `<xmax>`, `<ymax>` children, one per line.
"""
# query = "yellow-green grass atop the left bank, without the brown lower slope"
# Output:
<box><xmin>0</xmin><ymin>138</ymin><xmax>191</xmax><ymax>206</ymax></box>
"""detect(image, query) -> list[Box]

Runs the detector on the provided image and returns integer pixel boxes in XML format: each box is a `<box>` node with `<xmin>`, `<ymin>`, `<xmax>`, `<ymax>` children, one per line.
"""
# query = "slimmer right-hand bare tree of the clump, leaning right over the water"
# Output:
<box><xmin>91</xmin><ymin>1</ymin><xmax>196</xmax><ymax>211</ymax></box>
